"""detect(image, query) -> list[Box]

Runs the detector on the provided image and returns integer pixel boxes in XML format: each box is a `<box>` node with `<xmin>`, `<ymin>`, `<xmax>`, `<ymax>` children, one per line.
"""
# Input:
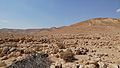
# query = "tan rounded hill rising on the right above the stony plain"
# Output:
<box><xmin>50</xmin><ymin>18</ymin><xmax>120</xmax><ymax>33</ymax></box>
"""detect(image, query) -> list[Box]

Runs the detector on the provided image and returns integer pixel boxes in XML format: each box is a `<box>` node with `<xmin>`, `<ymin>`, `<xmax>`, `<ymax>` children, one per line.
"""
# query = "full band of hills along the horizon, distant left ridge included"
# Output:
<box><xmin>0</xmin><ymin>18</ymin><xmax>120</xmax><ymax>35</ymax></box>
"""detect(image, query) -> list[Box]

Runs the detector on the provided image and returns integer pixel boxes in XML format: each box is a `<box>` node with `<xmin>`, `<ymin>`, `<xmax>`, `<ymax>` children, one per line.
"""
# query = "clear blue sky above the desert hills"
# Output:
<box><xmin>0</xmin><ymin>0</ymin><xmax>120</xmax><ymax>29</ymax></box>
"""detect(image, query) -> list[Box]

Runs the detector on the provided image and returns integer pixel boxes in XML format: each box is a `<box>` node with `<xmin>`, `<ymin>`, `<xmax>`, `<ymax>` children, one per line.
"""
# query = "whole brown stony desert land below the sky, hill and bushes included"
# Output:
<box><xmin>0</xmin><ymin>18</ymin><xmax>120</xmax><ymax>68</ymax></box>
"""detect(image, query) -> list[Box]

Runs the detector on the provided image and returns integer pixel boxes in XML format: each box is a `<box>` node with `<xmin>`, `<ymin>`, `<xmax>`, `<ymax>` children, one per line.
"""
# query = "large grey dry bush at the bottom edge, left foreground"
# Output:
<box><xmin>7</xmin><ymin>53</ymin><xmax>52</xmax><ymax>68</ymax></box>
